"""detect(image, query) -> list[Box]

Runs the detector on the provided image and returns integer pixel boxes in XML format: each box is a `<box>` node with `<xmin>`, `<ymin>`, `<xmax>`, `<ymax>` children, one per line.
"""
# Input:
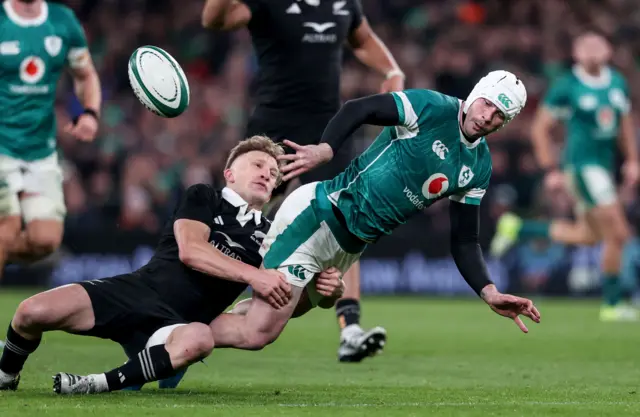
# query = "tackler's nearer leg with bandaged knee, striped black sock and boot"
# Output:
<box><xmin>53</xmin><ymin>323</ymin><xmax>214</xmax><ymax>394</ymax></box>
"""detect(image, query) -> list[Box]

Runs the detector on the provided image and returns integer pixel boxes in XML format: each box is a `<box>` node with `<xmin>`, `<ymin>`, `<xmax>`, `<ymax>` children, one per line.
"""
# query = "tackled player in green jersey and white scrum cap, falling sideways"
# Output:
<box><xmin>200</xmin><ymin>71</ymin><xmax>540</xmax><ymax>349</ymax></box>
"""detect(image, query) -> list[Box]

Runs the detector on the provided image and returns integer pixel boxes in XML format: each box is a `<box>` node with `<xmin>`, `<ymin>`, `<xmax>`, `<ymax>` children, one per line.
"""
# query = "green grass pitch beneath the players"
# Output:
<box><xmin>0</xmin><ymin>290</ymin><xmax>640</xmax><ymax>417</ymax></box>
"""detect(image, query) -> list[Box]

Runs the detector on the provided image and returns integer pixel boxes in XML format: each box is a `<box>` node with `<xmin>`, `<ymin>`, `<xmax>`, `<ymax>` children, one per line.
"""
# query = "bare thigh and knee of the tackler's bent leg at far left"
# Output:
<box><xmin>13</xmin><ymin>284</ymin><xmax>95</xmax><ymax>332</ymax></box>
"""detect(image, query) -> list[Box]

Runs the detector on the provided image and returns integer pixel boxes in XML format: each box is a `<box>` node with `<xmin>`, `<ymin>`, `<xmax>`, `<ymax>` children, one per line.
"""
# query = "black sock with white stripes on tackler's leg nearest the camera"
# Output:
<box><xmin>105</xmin><ymin>345</ymin><xmax>174</xmax><ymax>391</ymax></box>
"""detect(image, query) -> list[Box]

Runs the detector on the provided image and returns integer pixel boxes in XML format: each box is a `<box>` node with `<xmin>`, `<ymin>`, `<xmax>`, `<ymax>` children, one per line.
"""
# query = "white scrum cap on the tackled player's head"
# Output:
<box><xmin>463</xmin><ymin>70</ymin><xmax>527</xmax><ymax>124</ymax></box>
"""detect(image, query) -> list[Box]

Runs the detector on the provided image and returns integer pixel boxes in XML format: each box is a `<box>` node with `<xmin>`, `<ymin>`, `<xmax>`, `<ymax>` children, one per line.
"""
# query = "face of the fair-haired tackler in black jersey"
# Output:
<box><xmin>225</xmin><ymin>151</ymin><xmax>280</xmax><ymax>207</ymax></box>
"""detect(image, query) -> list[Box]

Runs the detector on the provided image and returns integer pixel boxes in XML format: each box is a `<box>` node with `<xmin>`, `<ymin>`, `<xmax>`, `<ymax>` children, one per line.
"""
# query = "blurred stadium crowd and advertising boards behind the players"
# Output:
<box><xmin>0</xmin><ymin>0</ymin><xmax>640</xmax><ymax>296</ymax></box>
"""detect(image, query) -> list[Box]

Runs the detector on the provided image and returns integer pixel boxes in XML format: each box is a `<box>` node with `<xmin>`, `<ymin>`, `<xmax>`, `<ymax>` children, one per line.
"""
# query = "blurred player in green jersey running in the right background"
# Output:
<box><xmin>491</xmin><ymin>33</ymin><xmax>640</xmax><ymax>321</ymax></box>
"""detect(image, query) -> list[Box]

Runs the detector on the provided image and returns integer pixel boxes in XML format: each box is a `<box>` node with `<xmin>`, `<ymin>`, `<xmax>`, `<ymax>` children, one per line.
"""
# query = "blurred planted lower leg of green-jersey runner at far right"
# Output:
<box><xmin>588</xmin><ymin>202</ymin><xmax>638</xmax><ymax>321</ymax></box>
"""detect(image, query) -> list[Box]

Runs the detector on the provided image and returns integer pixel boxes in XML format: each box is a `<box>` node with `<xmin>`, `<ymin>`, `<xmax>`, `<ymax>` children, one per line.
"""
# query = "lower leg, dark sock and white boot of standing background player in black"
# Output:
<box><xmin>336</xmin><ymin>261</ymin><xmax>387</xmax><ymax>362</ymax></box>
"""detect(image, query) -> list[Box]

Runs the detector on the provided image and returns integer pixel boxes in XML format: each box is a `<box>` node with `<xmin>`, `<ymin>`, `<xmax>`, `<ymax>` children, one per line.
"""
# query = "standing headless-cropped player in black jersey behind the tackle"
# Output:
<box><xmin>202</xmin><ymin>0</ymin><xmax>405</xmax><ymax>362</ymax></box>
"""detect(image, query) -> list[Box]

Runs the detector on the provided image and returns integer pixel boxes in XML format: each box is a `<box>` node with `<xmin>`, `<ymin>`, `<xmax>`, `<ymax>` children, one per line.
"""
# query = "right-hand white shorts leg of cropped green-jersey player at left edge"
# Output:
<box><xmin>20</xmin><ymin>153</ymin><xmax>66</xmax><ymax>224</ymax></box>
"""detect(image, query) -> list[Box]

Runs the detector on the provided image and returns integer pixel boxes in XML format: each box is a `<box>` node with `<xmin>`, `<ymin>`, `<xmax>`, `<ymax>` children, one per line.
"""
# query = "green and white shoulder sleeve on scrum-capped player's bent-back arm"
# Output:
<box><xmin>391</xmin><ymin>89</ymin><xmax>450</xmax><ymax>139</ymax></box>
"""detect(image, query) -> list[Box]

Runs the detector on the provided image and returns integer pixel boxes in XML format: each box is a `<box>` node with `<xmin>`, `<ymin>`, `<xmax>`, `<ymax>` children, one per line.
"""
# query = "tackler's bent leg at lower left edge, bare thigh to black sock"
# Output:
<box><xmin>0</xmin><ymin>284</ymin><xmax>95</xmax><ymax>390</ymax></box>
